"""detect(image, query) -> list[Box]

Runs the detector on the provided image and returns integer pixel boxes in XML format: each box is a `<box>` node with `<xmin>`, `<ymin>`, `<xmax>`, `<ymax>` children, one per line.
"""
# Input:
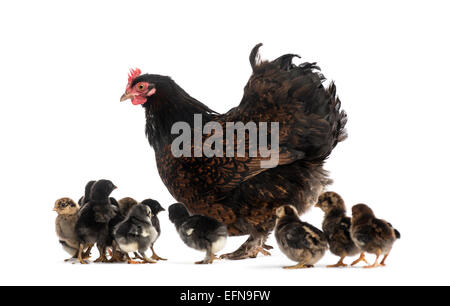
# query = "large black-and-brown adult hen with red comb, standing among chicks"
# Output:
<box><xmin>121</xmin><ymin>44</ymin><xmax>347</xmax><ymax>259</ymax></box>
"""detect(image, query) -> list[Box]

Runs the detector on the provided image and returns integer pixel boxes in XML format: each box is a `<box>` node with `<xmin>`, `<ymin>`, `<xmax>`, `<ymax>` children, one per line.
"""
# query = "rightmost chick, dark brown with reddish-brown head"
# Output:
<box><xmin>350</xmin><ymin>204</ymin><xmax>400</xmax><ymax>268</ymax></box>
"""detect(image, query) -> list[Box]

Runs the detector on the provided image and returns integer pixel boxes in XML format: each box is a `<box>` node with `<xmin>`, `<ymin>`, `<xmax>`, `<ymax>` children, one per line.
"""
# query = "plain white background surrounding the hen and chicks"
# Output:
<box><xmin>0</xmin><ymin>1</ymin><xmax>450</xmax><ymax>285</ymax></box>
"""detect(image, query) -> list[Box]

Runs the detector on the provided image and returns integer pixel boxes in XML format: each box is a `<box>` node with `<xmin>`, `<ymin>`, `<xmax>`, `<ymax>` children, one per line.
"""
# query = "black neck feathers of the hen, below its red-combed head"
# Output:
<box><xmin>144</xmin><ymin>80</ymin><xmax>217</xmax><ymax>153</ymax></box>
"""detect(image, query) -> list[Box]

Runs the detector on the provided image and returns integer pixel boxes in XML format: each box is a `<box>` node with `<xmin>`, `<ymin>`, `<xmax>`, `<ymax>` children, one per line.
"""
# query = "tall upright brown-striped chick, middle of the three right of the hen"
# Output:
<box><xmin>315</xmin><ymin>191</ymin><xmax>360</xmax><ymax>268</ymax></box>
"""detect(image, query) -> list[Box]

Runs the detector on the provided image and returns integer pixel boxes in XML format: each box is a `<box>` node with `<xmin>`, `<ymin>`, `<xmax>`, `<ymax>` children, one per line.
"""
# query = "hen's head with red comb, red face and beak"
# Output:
<box><xmin>120</xmin><ymin>68</ymin><xmax>170</xmax><ymax>105</ymax></box>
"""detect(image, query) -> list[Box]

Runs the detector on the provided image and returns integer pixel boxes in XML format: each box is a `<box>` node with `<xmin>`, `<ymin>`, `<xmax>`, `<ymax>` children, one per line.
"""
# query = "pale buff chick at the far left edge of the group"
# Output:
<box><xmin>53</xmin><ymin>198</ymin><xmax>80</xmax><ymax>261</ymax></box>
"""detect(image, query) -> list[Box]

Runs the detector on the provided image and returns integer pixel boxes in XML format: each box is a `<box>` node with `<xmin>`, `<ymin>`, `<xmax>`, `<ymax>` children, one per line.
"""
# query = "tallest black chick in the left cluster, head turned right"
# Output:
<box><xmin>75</xmin><ymin>180</ymin><xmax>118</xmax><ymax>263</ymax></box>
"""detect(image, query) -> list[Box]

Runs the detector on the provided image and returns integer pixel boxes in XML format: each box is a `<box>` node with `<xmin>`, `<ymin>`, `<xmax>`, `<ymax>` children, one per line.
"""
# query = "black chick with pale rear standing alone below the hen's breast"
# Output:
<box><xmin>169</xmin><ymin>203</ymin><xmax>228</xmax><ymax>264</ymax></box>
